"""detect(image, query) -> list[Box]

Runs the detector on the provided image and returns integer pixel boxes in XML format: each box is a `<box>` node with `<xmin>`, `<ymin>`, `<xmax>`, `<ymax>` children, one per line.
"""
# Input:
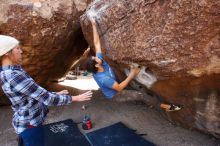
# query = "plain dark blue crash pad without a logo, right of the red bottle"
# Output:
<box><xmin>86</xmin><ymin>122</ymin><xmax>155</xmax><ymax>146</ymax></box>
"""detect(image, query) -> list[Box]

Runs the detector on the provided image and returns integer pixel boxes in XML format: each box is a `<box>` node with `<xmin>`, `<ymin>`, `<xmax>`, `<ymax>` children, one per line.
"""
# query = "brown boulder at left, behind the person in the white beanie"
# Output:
<box><xmin>0</xmin><ymin>0</ymin><xmax>90</xmax><ymax>104</ymax></box>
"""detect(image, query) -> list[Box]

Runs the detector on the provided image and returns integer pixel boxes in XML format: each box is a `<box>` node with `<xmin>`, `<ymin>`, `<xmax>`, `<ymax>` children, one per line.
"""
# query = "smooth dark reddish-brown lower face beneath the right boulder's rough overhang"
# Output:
<box><xmin>152</xmin><ymin>75</ymin><xmax>220</xmax><ymax>137</ymax></box>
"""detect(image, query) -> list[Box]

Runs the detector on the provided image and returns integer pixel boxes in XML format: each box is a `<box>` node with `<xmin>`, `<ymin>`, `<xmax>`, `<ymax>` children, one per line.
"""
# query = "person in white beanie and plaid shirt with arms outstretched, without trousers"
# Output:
<box><xmin>0</xmin><ymin>35</ymin><xmax>92</xmax><ymax>134</ymax></box>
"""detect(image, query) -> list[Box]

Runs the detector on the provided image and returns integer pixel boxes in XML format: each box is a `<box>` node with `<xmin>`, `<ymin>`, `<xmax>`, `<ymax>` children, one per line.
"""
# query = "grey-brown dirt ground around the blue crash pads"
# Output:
<box><xmin>0</xmin><ymin>91</ymin><xmax>220</xmax><ymax>146</ymax></box>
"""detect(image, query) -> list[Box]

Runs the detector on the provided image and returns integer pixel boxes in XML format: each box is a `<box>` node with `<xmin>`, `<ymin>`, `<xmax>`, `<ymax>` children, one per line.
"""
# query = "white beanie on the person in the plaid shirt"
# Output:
<box><xmin>0</xmin><ymin>35</ymin><xmax>19</xmax><ymax>56</ymax></box>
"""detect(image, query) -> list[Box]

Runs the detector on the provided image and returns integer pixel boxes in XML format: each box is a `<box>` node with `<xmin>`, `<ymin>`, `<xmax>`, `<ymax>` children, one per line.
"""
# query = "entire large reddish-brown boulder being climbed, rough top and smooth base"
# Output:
<box><xmin>81</xmin><ymin>0</ymin><xmax>220</xmax><ymax>137</ymax></box>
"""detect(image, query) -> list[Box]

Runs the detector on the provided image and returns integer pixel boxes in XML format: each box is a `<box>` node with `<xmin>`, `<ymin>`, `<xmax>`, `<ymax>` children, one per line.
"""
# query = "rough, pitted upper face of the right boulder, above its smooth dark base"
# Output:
<box><xmin>82</xmin><ymin>0</ymin><xmax>220</xmax><ymax>77</ymax></box>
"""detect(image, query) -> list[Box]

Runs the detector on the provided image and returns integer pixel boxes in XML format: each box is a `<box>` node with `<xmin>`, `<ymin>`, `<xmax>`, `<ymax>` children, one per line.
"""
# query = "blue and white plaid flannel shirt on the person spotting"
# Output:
<box><xmin>0</xmin><ymin>65</ymin><xmax>72</xmax><ymax>134</ymax></box>
